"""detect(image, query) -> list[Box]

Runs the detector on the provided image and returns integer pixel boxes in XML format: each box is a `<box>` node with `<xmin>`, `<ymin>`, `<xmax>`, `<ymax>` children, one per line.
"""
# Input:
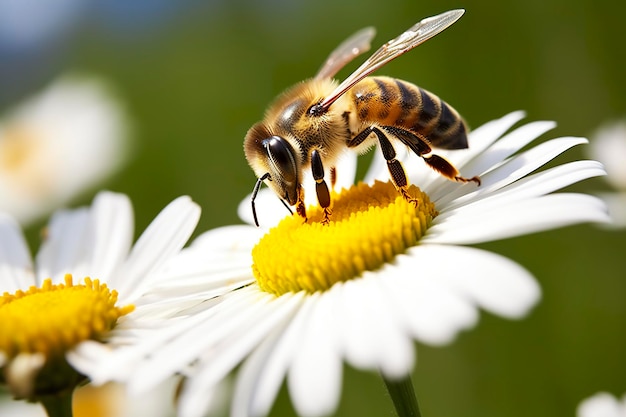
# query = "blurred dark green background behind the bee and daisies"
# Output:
<box><xmin>0</xmin><ymin>0</ymin><xmax>626</xmax><ymax>417</ymax></box>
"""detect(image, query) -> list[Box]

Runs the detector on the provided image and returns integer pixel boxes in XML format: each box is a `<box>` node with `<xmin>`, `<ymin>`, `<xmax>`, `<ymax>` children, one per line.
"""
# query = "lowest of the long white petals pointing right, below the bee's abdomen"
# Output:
<box><xmin>422</xmin><ymin>193</ymin><xmax>610</xmax><ymax>244</ymax></box>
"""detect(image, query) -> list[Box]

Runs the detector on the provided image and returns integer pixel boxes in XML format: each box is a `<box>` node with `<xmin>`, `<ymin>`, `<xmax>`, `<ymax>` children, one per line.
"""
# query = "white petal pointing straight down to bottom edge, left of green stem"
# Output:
<box><xmin>288</xmin><ymin>293</ymin><xmax>343</xmax><ymax>417</ymax></box>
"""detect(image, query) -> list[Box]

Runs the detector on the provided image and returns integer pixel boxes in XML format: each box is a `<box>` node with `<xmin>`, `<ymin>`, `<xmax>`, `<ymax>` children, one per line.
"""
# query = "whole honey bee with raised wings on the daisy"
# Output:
<box><xmin>244</xmin><ymin>9</ymin><xmax>480</xmax><ymax>226</ymax></box>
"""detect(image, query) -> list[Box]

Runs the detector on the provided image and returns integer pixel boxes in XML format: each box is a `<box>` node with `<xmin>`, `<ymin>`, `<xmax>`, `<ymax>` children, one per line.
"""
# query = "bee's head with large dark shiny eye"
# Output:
<box><xmin>244</xmin><ymin>124</ymin><xmax>301</xmax><ymax>213</ymax></box>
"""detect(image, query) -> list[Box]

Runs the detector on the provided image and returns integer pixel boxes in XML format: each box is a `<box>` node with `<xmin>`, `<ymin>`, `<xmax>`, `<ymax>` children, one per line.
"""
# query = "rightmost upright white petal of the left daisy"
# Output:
<box><xmin>116</xmin><ymin>197</ymin><xmax>200</xmax><ymax>303</ymax></box>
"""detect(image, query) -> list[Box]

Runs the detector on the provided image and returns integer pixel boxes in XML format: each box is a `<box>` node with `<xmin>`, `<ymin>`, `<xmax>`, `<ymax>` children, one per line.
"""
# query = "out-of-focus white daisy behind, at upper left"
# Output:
<box><xmin>0</xmin><ymin>76</ymin><xmax>128</xmax><ymax>224</ymax></box>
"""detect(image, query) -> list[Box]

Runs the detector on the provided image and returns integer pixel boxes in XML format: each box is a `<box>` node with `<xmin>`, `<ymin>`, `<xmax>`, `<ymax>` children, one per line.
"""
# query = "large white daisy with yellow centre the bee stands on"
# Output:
<box><xmin>74</xmin><ymin>112</ymin><xmax>607</xmax><ymax>417</ymax></box>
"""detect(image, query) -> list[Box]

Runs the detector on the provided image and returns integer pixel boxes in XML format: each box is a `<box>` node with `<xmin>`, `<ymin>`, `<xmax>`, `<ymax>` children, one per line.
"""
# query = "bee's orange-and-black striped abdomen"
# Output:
<box><xmin>350</xmin><ymin>77</ymin><xmax>467</xmax><ymax>149</ymax></box>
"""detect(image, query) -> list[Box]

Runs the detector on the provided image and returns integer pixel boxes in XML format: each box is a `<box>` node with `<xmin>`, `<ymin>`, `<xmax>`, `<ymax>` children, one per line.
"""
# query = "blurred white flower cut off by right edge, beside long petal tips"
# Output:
<box><xmin>589</xmin><ymin>120</ymin><xmax>626</xmax><ymax>227</ymax></box>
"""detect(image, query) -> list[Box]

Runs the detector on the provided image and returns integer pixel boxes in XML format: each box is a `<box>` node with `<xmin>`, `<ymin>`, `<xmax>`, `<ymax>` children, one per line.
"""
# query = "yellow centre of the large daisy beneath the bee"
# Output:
<box><xmin>252</xmin><ymin>182</ymin><xmax>436</xmax><ymax>295</ymax></box>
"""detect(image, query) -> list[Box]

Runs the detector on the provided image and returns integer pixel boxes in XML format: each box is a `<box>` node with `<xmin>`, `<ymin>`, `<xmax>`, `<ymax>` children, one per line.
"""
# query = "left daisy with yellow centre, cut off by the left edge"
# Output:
<box><xmin>0</xmin><ymin>192</ymin><xmax>200</xmax><ymax>411</ymax></box>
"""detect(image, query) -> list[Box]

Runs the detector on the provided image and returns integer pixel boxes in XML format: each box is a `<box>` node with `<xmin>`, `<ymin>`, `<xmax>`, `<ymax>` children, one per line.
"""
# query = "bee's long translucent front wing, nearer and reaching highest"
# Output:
<box><xmin>318</xmin><ymin>9</ymin><xmax>465</xmax><ymax>112</ymax></box>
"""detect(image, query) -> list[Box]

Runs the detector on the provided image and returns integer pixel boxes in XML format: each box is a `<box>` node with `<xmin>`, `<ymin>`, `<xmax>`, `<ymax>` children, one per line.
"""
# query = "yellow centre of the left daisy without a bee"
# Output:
<box><xmin>0</xmin><ymin>274</ymin><xmax>134</xmax><ymax>358</ymax></box>
